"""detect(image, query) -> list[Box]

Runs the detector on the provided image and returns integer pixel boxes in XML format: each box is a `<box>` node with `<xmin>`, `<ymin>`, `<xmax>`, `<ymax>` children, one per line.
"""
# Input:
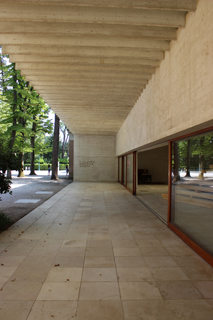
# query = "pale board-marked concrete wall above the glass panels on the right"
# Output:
<box><xmin>116</xmin><ymin>0</ymin><xmax>213</xmax><ymax>155</ymax></box>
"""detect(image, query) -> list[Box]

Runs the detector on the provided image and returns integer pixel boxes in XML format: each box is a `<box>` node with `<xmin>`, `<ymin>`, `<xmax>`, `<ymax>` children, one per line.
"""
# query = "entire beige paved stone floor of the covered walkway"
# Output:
<box><xmin>0</xmin><ymin>182</ymin><xmax>213</xmax><ymax>320</ymax></box>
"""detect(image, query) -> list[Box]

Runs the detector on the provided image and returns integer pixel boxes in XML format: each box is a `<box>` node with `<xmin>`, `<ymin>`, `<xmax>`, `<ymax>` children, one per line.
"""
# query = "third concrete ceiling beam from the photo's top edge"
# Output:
<box><xmin>0</xmin><ymin>21</ymin><xmax>177</xmax><ymax>40</ymax></box>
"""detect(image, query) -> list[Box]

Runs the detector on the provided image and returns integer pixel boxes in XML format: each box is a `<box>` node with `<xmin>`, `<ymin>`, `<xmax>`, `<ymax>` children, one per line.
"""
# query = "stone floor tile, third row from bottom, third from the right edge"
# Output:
<box><xmin>117</xmin><ymin>267</ymin><xmax>153</xmax><ymax>281</ymax></box>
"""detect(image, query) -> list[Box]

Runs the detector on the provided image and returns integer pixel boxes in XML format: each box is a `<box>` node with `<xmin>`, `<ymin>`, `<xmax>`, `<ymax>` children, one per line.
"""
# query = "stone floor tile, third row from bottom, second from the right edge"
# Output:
<box><xmin>149</xmin><ymin>267</ymin><xmax>189</xmax><ymax>281</ymax></box>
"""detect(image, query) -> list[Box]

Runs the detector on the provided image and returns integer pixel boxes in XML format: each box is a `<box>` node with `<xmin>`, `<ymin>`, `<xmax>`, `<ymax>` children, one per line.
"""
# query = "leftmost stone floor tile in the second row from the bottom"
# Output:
<box><xmin>0</xmin><ymin>280</ymin><xmax>42</xmax><ymax>301</ymax></box>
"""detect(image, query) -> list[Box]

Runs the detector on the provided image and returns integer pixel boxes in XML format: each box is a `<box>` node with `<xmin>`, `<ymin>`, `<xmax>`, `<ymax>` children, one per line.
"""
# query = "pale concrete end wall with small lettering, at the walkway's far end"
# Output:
<box><xmin>74</xmin><ymin>135</ymin><xmax>117</xmax><ymax>182</ymax></box>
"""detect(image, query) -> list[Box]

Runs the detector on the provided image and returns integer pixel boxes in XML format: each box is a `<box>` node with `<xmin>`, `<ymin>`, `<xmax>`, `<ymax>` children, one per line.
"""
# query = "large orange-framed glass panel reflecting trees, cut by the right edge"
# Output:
<box><xmin>171</xmin><ymin>132</ymin><xmax>213</xmax><ymax>254</ymax></box>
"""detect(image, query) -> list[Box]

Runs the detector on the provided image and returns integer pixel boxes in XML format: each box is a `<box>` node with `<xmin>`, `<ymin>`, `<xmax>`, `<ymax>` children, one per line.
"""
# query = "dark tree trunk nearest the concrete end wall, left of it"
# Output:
<box><xmin>51</xmin><ymin>114</ymin><xmax>60</xmax><ymax>180</ymax></box>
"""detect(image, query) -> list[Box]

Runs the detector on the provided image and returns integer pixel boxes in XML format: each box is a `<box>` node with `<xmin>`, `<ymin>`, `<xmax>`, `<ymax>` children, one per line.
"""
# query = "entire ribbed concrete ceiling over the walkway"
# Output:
<box><xmin>0</xmin><ymin>0</ymin><xmax>196</xmax><ymax>135</ymax></box>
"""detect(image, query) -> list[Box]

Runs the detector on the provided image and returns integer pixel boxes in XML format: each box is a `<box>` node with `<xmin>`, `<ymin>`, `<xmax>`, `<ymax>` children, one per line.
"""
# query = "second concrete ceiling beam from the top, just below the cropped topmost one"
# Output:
<box><xmin>0</xmin><ymin>2</ymin><xmax>187</xmax><ymax>28</ymax></box>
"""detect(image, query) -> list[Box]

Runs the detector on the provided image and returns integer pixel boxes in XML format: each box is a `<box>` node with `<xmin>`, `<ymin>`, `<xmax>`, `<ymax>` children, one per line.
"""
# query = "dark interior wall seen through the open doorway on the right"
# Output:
<box><xmin>138</xmin><ymin>146</ymin><xmax>168</xmax><ymax>184</ymax></box>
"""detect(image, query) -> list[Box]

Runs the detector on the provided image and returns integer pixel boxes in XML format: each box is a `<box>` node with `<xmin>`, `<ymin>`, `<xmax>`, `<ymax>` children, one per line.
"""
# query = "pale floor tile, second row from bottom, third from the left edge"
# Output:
<box><xmin>79</xmin><ymin>281</ymin><xmax>120</xmax><ymax>300</ymax></box>
